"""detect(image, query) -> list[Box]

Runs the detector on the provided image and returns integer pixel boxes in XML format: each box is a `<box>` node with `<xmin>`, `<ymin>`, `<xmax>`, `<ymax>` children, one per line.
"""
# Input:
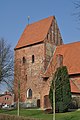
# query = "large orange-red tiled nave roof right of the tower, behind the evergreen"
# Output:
<box><xmin>45</xmin><ymin>42</ymin><xmax>80</xmax><ymax>76</ymax></box>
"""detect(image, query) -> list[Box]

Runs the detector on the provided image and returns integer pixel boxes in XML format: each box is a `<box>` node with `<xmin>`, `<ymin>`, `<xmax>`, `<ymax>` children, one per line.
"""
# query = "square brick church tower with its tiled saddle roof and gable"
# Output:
<box><xmin>14</xmin><ymin>16</ymin><xmax>63</xmax><ymax>107</ymax></box>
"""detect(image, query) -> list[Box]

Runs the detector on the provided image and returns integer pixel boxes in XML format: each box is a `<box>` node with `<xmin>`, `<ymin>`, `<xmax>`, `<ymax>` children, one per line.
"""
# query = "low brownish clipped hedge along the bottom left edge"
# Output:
<box><xmin>0</xmin><ymin>114</ymin><xmax>40</xmax><ymax>120</ymax></box>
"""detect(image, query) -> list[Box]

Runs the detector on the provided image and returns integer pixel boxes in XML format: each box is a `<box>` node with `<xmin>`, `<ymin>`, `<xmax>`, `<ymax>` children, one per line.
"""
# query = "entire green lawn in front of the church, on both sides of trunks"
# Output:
<box><xmin>0</xmin><ymin>109</ymin><xmax>80</xmax><ymax>120</ymax></box>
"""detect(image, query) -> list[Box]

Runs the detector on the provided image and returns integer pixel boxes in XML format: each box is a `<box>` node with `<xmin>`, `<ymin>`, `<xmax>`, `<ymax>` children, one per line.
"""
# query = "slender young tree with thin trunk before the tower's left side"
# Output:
<box><xmin>14</xmin><ymin>58</ymin><xmax>21</xmax><ymax>116</ymax></box>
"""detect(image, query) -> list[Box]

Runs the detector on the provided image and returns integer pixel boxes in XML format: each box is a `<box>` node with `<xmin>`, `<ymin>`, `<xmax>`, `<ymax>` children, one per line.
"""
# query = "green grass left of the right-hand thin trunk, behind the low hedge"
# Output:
<box><xmin>0</xmin><ymin>109</ymin><xmax>53</xmax><ymax>120</ymax></box>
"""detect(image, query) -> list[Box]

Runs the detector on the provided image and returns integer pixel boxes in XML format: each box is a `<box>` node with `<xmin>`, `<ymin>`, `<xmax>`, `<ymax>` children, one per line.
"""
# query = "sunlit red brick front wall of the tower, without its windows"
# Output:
<box><xmin>14</xmin><ymin>43</ymin><xmax>44</xmax><ymax>102</ymax></box>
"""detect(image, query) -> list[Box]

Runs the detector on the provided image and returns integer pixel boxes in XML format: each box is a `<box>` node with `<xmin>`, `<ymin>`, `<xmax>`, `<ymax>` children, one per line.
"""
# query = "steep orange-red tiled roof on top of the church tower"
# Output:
<box><xmin>15</xmin><ymin>16</ymin><xmax>54</xmax><ymax>49</ymax></box>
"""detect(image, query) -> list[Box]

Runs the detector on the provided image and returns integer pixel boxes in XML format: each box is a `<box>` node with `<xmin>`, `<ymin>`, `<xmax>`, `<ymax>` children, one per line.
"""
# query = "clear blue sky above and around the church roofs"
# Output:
<box><xmin>0</xmin><ymin>0</ymin><xmax>80</xmax><ymax>92</ymax></box>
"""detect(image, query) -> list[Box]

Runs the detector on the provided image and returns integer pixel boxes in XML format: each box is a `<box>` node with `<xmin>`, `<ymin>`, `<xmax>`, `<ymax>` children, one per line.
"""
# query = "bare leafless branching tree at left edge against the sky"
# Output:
<box><xmin>0</xmin><ymin>39</ymin><xmax>13</xmax><ymax>87</ymax></box>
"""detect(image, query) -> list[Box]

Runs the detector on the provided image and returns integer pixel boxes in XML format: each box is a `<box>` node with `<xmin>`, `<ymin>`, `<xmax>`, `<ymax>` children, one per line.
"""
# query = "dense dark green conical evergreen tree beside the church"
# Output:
<box><xmin>49</xmin><ymin>66</ymin><xmax>71</xmax><ymax>112</ymax></box>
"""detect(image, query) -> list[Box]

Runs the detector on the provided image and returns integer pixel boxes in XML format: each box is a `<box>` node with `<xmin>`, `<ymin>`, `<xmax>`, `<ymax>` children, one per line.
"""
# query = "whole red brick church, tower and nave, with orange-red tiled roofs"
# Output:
<box><xmin>14</xmin><ymin>16</ymin><xmax>80</xmax><ymax>109</ymax></box>
